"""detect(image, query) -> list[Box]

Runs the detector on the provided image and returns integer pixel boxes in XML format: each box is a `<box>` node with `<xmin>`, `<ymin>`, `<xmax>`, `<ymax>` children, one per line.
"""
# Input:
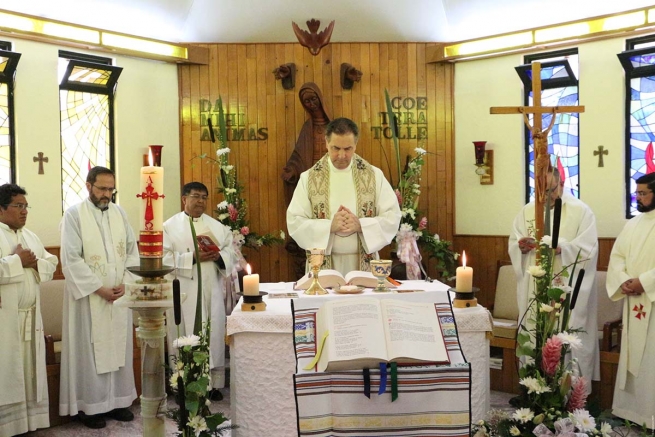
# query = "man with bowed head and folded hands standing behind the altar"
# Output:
<box><xmin>287</xmin><ymin>118</ymin><xmax>401</xmax><ymax>275</ymax></box>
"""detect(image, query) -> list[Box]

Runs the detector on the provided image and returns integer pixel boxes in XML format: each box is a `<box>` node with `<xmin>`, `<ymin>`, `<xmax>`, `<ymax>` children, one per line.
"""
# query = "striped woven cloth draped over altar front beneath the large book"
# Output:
<box><xmin>293</xmin><ymin>292</ymin><xmax>471</xmax><ymax>437</ymax></box>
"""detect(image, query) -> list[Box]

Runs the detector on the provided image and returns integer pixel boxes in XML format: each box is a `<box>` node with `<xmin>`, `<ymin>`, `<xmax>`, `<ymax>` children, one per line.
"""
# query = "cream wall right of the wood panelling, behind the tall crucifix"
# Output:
<box><xmin>455</xmin><ymin>38</ymin><xmax>626</xmax><ymax>237</ymax></box>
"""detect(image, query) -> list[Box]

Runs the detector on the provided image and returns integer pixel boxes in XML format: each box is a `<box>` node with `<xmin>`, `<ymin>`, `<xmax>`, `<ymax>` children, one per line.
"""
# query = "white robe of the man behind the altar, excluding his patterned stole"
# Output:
<box><xmin>287</xmin><ymin>159</ymin><xmax>400</xmax><ymax>275</ymax></box>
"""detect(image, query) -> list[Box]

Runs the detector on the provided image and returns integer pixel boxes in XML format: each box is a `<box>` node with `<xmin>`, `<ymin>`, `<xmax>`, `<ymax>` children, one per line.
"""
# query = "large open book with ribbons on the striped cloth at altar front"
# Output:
<box><xmin>305</xmin><ymin>297</ymin><xmax>450</xmax><ymax>372</ymax></box>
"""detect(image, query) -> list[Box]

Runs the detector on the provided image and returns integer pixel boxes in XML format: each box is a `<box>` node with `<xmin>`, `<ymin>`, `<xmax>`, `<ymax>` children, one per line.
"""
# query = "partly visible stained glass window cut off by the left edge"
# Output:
<box><xmin>0</xmin><ymin>41</ymin><xmax>21</xmax><ymax>184</ymax></box>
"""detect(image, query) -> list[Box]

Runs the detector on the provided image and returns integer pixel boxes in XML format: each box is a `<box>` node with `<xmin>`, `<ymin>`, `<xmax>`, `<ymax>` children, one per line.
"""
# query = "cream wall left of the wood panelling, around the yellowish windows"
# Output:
<box><xmin>3</xmin><ymin>38</ymin><xmax>180</xmax><ymax>246</ymax></box>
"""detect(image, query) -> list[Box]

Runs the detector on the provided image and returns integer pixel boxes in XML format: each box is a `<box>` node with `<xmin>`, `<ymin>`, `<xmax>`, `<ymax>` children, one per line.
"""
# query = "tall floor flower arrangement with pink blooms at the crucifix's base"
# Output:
<box><xmin>474</xmin><ymin>218</ymin><xmax>612</xmax><ymax>437</ymax></box>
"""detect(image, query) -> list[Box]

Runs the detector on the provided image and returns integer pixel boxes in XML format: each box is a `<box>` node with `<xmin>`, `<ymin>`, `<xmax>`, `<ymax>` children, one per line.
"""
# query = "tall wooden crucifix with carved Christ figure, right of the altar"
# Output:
<box><xmin>490</xmin><ymin>62</ymin><xmax>584</xmax><ymax>245</ymax></box>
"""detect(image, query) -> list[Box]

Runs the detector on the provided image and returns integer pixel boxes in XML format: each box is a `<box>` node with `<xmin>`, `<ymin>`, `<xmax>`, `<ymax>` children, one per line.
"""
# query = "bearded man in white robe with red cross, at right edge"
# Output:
<box><xmin>607</xmin><ymin>173</ymin><xmax>655</xmax><ymax>428</ymax></box>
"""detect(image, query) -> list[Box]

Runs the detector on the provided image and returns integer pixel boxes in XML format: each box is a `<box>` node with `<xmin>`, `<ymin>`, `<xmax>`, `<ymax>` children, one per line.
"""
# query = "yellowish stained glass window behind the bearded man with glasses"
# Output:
<box><xmin>59</xmin><ymin>52</ymin><xmax>122</xmax><ymax>210</ymax></box>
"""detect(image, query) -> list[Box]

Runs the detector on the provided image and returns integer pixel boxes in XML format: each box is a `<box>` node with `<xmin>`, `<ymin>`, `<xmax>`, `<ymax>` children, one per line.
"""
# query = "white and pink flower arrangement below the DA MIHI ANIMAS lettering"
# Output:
<box><xmin>199</xmin><ymin>97</ymin><xmax>286</xmax><ymax>250</ymax></box>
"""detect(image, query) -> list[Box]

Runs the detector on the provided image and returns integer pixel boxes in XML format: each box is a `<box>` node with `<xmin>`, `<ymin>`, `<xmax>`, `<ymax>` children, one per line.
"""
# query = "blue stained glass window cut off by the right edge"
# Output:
<box><xmin>618</xmin><ymin>36</ymin><xmax>655</xmax><ymax>218</ymax></box>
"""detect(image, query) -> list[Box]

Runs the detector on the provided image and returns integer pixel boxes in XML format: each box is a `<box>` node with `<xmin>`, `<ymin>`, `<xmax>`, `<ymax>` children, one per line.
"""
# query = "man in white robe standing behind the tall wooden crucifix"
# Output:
<box><xmin>509</xmin><ymin>171</ymin><xmax>600</xmax><ymax>384</ymax></box>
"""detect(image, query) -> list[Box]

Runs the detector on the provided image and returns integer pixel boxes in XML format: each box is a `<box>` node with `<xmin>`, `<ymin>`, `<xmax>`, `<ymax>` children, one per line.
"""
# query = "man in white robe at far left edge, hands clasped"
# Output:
<box><xmin>0</xmin><ymin>184</ymin><xmax>57</xmax><ymax>436</ymax></box>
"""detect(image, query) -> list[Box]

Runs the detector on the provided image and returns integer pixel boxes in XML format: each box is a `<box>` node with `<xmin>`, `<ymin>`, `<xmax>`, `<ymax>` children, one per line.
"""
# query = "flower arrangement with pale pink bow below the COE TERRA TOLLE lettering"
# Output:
<box><xmin>383</xmin><ymin>90</ymin><xmax>459</xmax><ymax>280</ymax></box>
